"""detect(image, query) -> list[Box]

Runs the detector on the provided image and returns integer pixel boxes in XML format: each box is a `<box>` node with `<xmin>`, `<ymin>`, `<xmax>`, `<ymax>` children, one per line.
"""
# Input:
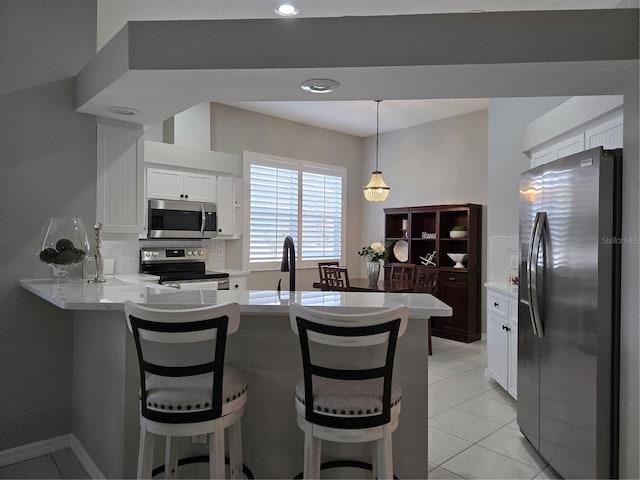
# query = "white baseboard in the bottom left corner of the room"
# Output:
<box><xmin>0</xmin><ymin>433</ymin><xmax>104</xmax><ymax>478</ymax></box>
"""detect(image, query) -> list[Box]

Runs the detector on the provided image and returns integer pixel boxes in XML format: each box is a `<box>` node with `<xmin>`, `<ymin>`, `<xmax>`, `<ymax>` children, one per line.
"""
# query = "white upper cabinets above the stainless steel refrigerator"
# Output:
<box><xmin>523</xmin><ymin>95</ymin><xmax>623</xmax><ymax>168</ymax></box>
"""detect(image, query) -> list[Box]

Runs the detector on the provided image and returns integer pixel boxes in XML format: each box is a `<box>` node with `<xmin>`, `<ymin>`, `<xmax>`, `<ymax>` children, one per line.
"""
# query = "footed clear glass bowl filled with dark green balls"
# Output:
<box><xmin>37</xmin><ymin>217</ymin><xmax>89</xmax><ymax>278</ymax></box>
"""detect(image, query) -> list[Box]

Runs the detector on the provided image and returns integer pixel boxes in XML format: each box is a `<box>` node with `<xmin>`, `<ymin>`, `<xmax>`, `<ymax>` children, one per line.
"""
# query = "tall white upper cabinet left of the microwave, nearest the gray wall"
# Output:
<box><xmin>96</xmin><ymin>119</ymin><xmax>144</xmax><ymax>235</ymax></box>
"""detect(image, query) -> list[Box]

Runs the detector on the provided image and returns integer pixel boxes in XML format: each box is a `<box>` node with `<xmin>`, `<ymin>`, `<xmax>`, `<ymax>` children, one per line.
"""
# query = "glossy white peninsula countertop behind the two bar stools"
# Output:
<box><xmin>19</xmin><ymin>274</ymin><xmax>452</xmax><ymax>318</ymax></box>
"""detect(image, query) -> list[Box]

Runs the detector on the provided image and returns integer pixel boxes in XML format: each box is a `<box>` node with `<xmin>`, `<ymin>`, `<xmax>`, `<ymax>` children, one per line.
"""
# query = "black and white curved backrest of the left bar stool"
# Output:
<box><xmin>124</xmin><ymin>301</ymin><xmax>240</xmax><ymax>423</ymax></box>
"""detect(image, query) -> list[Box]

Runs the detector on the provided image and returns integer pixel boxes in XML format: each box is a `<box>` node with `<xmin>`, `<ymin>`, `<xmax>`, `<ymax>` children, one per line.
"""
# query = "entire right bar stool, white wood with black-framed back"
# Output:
<box><xmin>289</xmin><ymin>303</ymin><xmax>408</xmax><ymax>479</ymax></box>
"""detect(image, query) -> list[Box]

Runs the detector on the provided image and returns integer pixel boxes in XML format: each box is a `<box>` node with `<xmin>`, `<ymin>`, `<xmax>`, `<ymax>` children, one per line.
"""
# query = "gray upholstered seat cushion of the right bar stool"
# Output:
<box><xmin>295</xmin><ymin>376</ymin><xmax>402</xmax><ymax>416</ymax></box>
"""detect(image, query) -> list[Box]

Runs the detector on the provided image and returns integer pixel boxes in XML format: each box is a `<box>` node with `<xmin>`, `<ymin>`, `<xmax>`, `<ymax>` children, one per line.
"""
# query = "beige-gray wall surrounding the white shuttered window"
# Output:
<box><xmin>211</xmin><ymin>103</ymin><xmax>364</xmax><ymax>290</ymax></box>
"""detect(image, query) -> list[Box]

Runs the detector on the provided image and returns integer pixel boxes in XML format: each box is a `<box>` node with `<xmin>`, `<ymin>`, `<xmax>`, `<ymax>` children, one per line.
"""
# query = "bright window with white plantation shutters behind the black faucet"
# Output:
<box><xmin>244</xmin><ymin>152</ymin><xmax>346</xmax><ymax>269</ymax></box>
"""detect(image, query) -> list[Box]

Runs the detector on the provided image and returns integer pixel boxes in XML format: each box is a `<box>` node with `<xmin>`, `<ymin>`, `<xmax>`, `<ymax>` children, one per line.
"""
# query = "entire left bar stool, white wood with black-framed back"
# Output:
<box><xmin>124</xmin><ymin>301</ymin><xmax>247</xmax><ymax>478</ymax></box>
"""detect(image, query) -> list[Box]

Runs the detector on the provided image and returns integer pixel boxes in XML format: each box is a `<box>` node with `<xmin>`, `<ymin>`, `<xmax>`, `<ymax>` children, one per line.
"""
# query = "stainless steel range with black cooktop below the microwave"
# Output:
<box><xmin>140</xmin><ymin>247</ymin><xmax>229</xmax><ymax>290</ymax></box>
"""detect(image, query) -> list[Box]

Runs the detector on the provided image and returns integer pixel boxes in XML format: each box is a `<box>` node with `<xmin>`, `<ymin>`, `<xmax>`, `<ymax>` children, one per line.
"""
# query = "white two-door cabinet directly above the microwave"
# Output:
<box><xmin>147</xmin><ymin>168</ymin><xmax>216</xmax><ymax>203</ymax></box>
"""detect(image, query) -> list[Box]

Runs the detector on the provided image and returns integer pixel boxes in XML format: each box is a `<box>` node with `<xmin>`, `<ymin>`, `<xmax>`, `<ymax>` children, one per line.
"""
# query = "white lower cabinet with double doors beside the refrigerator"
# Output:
<box><xmin>487</xmin><ymin>287</ymin><xmax>518</xmax><ymax>398</ymax></box>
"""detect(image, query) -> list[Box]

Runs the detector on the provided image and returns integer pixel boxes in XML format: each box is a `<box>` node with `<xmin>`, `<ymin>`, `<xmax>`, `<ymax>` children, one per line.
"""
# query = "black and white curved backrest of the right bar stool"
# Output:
<box><xmin>289</xmin><ymin>303</ymin><xmax>408</xmax><ymax>429</ymax></box>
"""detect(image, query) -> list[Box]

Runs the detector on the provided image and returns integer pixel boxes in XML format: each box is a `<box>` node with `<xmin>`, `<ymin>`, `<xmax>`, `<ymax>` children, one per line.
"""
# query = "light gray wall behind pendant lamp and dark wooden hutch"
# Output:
<box><xmin>360</xmin><ymin>109</ymin><xmax>488</xmax><ymax>332</ymax></box>
